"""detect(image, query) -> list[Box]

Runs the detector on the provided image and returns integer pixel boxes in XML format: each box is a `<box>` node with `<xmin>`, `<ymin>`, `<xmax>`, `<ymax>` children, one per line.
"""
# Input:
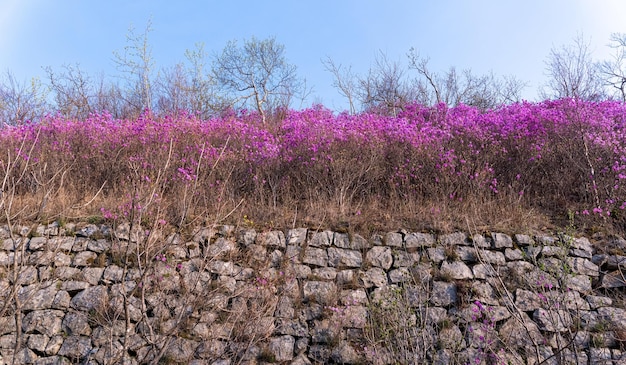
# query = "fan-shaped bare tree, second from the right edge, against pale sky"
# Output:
<box><xmin>541</xmin><ymin>35</ymin><xmax>606</xmax><ymax>100</ymax></box>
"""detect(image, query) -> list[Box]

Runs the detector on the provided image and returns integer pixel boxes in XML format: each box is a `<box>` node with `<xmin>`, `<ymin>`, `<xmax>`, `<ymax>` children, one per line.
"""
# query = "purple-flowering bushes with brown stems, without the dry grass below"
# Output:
<box><xmin>0</xmin><ymin>99</ymin><xmax>626</xmax><ymax>225</ymax></box>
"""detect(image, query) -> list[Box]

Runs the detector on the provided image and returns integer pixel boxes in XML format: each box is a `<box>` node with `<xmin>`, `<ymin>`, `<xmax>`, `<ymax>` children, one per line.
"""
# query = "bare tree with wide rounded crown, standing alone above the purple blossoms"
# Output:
<box><xmin>213</xmin><ymin>37</ymin><xmax>302</xmax><ymax>123</ymax></box>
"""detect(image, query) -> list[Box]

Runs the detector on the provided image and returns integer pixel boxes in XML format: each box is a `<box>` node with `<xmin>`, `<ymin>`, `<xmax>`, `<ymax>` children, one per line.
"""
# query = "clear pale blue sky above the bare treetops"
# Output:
<box><xmin>0</xmin><ymin>0</ymin><xmax>626</xmax><ymax>109</ymax></box>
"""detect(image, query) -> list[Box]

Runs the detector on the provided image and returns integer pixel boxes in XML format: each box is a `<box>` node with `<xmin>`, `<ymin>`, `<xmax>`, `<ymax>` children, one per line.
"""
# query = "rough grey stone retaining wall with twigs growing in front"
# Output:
<box><xmin>0</xmin><ymin>224</ymin><xmax>626</xmax><ymax>364</ymax></box>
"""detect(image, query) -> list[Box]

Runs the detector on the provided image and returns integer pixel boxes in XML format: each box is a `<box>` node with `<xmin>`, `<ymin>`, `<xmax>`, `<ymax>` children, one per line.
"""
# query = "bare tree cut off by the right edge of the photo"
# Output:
<box><xmin>598</xmin><ymin>33</ymin><xmax>626</xmax><ymax>102</ymax></box>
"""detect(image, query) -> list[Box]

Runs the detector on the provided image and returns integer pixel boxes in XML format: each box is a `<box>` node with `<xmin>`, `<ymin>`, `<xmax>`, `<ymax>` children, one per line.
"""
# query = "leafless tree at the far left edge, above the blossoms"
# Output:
<box><xmin>0</xmin><ymin>71</ymin><xmax>48</xmax><ymax>127</ymax></box>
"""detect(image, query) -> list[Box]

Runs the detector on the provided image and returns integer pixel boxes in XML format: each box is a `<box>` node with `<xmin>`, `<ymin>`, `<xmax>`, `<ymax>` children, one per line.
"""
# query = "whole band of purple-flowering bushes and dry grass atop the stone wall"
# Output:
<box><xmin>0</xmin><ymin>99</ymin><xmax>626</xmax><ymax>233</ymax></box>
